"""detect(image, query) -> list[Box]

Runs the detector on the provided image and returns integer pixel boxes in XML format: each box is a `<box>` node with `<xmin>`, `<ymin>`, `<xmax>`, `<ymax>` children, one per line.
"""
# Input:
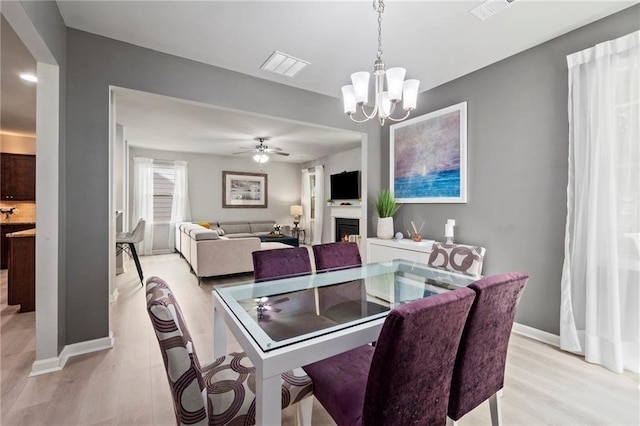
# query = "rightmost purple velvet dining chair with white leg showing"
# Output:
<box><xmin>448</xmin><ymin>272</ymin><xmax>529</xmax><ymax>426</ymax></box>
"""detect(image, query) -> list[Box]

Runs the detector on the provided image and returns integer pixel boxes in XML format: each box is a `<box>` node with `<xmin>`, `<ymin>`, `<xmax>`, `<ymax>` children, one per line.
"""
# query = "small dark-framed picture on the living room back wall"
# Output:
<box><xmin>222</xmin><ymin>170</ymin><xmax>269</xmax><ymax>208</ymax></box>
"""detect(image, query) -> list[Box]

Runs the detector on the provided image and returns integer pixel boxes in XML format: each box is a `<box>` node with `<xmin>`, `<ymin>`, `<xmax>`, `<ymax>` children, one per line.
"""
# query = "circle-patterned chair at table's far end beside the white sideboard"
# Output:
<box><xmin>429</xmin><ymin>241</ymin><xmax>486</xmax><ymax>277</ymax></box>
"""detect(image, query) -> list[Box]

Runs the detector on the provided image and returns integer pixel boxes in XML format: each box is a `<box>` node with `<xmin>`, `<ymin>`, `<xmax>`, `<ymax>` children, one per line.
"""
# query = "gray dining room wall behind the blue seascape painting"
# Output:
<box><xmin>382</xmin><ymin>6</ymin><xmax>640</xmax><ymax>334</ymax></box>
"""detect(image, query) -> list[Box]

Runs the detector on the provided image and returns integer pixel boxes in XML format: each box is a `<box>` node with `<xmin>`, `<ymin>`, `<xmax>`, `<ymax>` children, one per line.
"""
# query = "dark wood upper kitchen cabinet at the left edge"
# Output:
<box><xmin>0</xmin><ymin>154</ymin><xmax>36</xmax><ymax>201</ymax></box>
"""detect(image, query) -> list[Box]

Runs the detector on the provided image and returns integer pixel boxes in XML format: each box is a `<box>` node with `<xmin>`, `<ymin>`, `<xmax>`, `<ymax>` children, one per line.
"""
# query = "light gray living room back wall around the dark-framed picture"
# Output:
<box><xmin>129</xmin><ymin>147</ymin><xmax>301</xmax><ymax>251</ymax></box>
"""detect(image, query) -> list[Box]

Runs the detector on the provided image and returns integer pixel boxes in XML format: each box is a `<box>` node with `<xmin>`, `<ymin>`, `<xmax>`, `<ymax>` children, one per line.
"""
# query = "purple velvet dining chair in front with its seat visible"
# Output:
<box><xmin>304</xmin><ymin>288</ymin><xmax>475</xmax><ymax>426</ymax></box>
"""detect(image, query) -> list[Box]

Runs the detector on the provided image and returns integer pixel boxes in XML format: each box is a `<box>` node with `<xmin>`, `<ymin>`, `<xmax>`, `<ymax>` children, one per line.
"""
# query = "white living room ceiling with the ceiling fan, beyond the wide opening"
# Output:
<box><xmin>115</xmin><ymin>89</ymin><xmax>361</xmax><ymax>163</ymax></box>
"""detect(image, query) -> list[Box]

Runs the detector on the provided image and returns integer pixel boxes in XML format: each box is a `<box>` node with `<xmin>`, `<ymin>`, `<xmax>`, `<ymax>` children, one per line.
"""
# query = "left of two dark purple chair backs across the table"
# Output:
<box><xmin>251</xmin><ymin>247</ymin><xmax>311</xmax><ymax>282</ymax></box>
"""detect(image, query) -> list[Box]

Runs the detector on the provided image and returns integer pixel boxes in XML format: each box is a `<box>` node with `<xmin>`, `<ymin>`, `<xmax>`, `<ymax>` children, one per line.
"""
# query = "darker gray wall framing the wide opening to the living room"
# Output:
<box><xmin>64</xmin><ymin>29</ymin><xmax>380</xmax><ymax>344</ymax></box>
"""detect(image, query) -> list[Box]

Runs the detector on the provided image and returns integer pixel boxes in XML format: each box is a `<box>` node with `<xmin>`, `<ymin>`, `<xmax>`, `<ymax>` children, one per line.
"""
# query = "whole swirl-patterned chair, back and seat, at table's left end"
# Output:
<box><xmin>146</xmin><ymin>277</ymin><xmax>313</xmax><ymax>425</ymax></box>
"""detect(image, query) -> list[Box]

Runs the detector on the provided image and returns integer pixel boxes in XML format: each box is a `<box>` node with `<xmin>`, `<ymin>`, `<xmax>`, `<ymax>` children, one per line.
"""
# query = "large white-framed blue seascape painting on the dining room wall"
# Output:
<box><xmin>389</xmin><ymin>102</ymin><xmax>467</xmax><ymax>203</ymax></box>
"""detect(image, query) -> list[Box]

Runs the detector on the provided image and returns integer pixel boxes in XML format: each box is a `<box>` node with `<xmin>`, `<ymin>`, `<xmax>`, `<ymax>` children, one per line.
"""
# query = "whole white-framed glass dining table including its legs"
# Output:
<box><xmin>212</xmin><ymin>260</ymin><xmax>477</xmax><ymax>425</ymax></box>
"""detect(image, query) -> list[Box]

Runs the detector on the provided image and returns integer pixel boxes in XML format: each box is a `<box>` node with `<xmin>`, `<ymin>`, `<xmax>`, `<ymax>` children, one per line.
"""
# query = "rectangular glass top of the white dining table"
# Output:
<box><xmin>213</xmin><ymin>260</ymin><xmax>477</xmax><ymax>352</ymax></box>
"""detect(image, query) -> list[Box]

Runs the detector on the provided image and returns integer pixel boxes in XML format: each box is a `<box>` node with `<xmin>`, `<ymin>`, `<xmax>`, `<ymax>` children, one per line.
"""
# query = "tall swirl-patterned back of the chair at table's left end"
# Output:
<box><xmin>146</xmin><ymin>277</ymin><xmax>207</xmax><ymax>425</ymax></box>
